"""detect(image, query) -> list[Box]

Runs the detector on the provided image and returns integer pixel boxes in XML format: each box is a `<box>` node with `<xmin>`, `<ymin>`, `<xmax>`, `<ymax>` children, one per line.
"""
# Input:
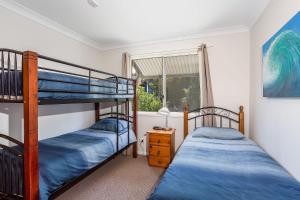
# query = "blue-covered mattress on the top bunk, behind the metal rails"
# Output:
<box><xmin>0</xmin><ymin>71</ymin><xmax>134</xmax><ymax>100</ymax></box>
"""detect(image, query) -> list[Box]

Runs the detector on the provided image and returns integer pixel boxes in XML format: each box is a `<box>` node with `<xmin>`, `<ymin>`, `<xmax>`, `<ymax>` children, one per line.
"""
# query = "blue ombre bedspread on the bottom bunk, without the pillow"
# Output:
<box><xmin>39</xmin><ymin>129</ymin><xmax>136</xmax><ymax>200</ymax></box>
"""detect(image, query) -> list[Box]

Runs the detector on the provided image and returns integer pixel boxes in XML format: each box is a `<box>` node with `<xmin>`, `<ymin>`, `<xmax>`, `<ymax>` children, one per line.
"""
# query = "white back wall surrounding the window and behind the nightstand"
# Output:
<box><xmin>102</xmin><ymin>31</ymin><xmax>250</xmax><ymax>155</ymax></box>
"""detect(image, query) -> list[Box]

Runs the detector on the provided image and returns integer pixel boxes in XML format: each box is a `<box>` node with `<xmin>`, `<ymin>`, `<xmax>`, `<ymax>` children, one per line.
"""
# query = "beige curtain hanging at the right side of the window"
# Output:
<box><xmin>198</xmin><ymin>44</ymin><xmax>216</xmax><ymax>126</ymax></box>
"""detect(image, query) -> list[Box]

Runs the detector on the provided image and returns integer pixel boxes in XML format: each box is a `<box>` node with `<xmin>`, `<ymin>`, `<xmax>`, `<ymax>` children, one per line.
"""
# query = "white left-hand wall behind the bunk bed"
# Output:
<box><xmin>0</xmin><ymin>6</ymin><xmax>104</xmax><ymax>140</ymax></box>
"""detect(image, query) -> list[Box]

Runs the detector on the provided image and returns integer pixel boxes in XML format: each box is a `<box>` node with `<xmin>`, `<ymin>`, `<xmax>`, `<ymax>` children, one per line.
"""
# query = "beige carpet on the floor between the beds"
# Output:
<box><xmin>57</xmin><ymin>155</ymin><xmax>163</xmax><ymax>200</ymax></box>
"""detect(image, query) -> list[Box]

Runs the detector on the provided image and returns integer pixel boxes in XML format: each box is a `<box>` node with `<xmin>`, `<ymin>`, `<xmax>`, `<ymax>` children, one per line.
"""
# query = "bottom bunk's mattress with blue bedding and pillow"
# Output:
<box><xmin>0</xmin><ymin>118</ymin><xmax>136</xmax><ymax>200</ymax></box>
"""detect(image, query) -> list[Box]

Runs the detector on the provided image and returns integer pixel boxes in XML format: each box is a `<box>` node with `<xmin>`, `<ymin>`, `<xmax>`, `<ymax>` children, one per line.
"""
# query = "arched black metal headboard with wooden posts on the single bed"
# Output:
<box><xmin>183</xmin><ymin>105</ymin><xmax>245</xmax><ymax>138</ymax></box>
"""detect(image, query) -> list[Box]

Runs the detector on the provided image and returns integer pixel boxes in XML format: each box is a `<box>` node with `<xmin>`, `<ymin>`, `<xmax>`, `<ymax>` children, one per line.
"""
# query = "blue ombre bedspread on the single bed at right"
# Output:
<box><xmin>149</xmin><ymin>134</ymin><xmax>300</xmax><ymax>200</ymax></box>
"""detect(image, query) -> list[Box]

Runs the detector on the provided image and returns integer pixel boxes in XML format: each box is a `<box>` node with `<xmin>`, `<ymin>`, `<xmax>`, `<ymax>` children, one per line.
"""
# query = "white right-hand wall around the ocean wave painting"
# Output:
<box><xmin>250</xmin><ymin>0</ymin><xmax>300</xmax><ymax>180</ymax></box>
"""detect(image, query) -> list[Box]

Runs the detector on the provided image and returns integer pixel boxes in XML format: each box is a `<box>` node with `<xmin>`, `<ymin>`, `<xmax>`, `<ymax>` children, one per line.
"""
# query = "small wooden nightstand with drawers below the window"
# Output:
<box><xmin>147</xmin><ymin>129</ymin><xmax>175</xmax><ymax>167</ymax></box>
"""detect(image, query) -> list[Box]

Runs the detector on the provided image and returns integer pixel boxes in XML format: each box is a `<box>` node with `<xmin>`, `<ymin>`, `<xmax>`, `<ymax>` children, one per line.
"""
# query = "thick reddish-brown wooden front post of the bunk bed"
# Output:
<box><xmin>23</xmin><ymin>51</ymin><xmax>39</xmax><ymax>200</ymax></box>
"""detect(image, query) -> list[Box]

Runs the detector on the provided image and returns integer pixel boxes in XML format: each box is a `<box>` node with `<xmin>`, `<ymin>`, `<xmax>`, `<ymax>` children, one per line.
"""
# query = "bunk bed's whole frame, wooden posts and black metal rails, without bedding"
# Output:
<box><xmin>0</xmin><ymin>49</ymin><xmax>138</xmax><ymax>200</ymax></box>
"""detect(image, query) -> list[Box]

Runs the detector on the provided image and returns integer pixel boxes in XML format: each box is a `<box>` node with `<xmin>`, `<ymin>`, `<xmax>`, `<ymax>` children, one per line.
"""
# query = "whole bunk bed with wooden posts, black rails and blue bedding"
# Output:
<box><xmin>0</xmin><ymin>49</ymin><xmax>137</xmax><ymax>200</ymax></box>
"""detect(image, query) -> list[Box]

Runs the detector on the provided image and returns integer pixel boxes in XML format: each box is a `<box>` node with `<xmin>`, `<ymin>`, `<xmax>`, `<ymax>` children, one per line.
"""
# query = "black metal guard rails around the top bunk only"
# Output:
<box><xmin>0</xmin><ymin>48</ymin><xmax>135</xmax><ymax>105</ymax></box>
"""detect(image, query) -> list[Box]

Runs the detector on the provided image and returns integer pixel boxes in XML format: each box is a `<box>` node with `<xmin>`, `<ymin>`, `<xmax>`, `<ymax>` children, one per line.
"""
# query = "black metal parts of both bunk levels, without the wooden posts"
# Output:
<box><xmin>0</xmin><ymin>48</ymin><xmax>136</xmax><ymax>200</ymax></box>
